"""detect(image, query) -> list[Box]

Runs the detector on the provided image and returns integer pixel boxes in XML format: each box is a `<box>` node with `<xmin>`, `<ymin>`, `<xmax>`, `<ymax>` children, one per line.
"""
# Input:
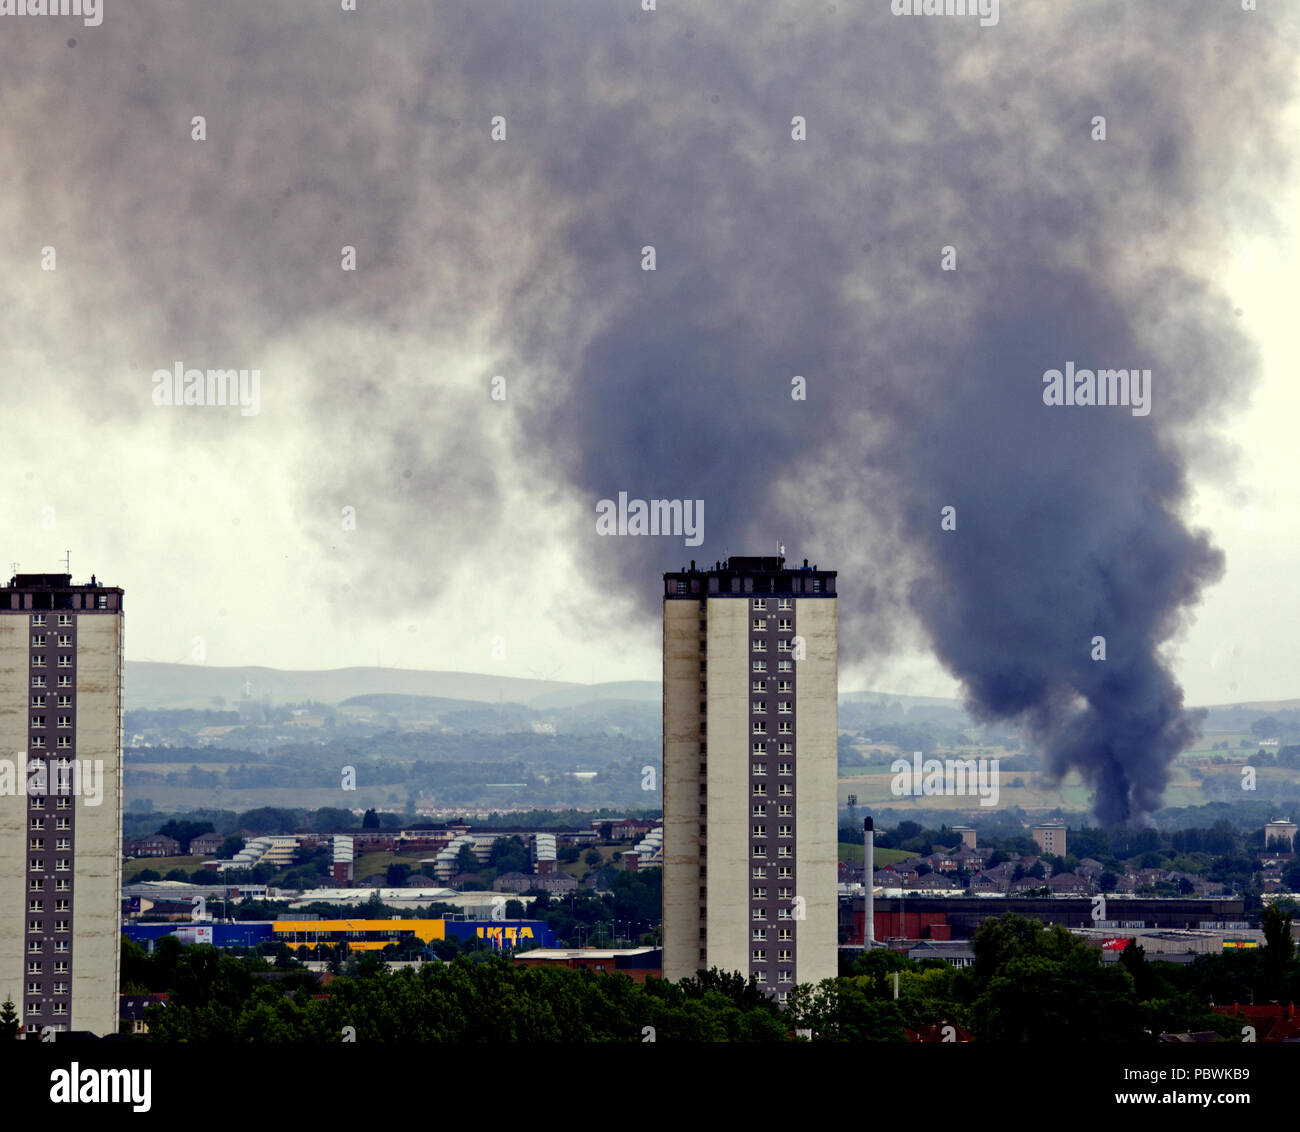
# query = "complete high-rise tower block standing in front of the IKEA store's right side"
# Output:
<box><xmin>663</xmin><ymin>558</ymin><xmax>839</xmax><ymax>999</ymax></box>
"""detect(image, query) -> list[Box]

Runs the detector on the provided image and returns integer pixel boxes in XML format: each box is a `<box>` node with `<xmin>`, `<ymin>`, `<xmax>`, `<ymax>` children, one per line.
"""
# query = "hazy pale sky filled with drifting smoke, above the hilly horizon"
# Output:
<box><xmin>0</xmin><ymin>0</ymin><xmax>1300</xmax><ymax>703</ymax></box>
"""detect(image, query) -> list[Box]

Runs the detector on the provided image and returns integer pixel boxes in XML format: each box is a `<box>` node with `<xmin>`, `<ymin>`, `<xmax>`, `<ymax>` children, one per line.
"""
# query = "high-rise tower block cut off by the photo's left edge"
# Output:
<box><xmin>0</xmin><ymin>574</ymin><xmax>122</xmax><ymax>1035</ymax></box>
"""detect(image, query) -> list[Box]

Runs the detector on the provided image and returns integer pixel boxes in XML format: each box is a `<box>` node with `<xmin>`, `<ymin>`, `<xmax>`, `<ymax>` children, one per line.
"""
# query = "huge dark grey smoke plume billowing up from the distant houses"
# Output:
<box><xmin>0</xmin><ymin>0</ymin><xmax>1297</xmax><ymax>821</ymax></box>
